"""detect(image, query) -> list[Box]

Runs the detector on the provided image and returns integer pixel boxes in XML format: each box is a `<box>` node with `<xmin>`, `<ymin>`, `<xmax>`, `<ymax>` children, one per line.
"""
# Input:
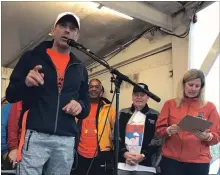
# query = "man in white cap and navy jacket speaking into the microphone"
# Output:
<box><xmin>6</xmin><ymin>12</ymin><xmax>90</xmax><ymax>175</ymax></box>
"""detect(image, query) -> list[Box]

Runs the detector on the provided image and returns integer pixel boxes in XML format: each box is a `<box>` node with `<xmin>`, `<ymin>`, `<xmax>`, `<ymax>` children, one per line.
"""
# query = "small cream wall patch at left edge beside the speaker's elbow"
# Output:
<box><xmin>1</xmin><ymin>67</ymin><xmax>13</xmax><ymax>97</ymax></box>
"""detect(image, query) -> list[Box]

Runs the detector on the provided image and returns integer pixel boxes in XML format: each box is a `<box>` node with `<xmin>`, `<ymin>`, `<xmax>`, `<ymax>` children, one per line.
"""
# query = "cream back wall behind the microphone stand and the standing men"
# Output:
<box><xmin>89</xmin><ymin>36</ymin><xmax>173</xmax><ymax>111</ymax></box>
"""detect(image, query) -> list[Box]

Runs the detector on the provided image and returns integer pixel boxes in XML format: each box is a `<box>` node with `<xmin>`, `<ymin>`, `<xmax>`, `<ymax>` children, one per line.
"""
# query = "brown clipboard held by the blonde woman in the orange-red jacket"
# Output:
<box><xmin>178</xmin><ymin>115</ymin><xmax>213</xmax><ymax>132</ymax></box>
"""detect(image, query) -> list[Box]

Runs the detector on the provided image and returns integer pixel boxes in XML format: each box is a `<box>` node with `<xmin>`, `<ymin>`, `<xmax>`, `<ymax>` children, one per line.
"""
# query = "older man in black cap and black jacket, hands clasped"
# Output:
<box><xmin>118</xmin><ymin>83</ymin><xmax>162</xmax><ymax>175</ymax></box>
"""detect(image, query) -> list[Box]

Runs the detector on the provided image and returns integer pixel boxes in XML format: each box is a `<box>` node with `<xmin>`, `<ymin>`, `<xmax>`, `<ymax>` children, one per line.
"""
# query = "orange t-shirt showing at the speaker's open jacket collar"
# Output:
<box><xmin>47</xmin><ymin>49</ymin><xmax>70</xmax><ymax>92</ymax></box>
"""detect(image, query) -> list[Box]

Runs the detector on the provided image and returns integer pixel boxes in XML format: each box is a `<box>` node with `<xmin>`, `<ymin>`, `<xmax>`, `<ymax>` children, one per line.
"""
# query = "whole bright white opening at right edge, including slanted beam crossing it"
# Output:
<box><xmin>189</xmin><ymin>2</ymin><xmax>220</xmax><ymax>112</ymax></box>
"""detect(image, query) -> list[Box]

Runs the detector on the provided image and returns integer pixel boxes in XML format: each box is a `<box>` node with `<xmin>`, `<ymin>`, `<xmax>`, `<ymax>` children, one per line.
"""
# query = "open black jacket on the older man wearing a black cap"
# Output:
<box><xmin>119</xmin><ymin>105</ymin><xmax>162</xmax><ymax>167</ymax></box>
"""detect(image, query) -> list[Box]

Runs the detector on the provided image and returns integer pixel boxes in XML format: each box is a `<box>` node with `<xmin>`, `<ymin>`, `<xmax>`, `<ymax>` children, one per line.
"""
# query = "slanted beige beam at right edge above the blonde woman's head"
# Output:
<box><xmin>200</xmin><ymin>34</ymin><xmax>220</xmax><ymax>75</ymax></box>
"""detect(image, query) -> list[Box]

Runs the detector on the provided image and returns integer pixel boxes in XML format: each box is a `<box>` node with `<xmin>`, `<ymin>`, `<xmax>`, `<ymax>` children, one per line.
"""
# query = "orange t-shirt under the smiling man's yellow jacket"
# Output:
<box><xmin>78</xmin><ymin>104</ymin><xmax>98</xmax><ymax>158</ymax></box>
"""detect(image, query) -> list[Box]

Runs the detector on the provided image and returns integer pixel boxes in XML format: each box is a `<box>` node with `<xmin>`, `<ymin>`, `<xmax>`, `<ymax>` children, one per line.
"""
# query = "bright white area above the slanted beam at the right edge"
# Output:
<box><xmin>189</xmin><ymin>2</ymin><xmax>220</xmax><ymax>69</ymax></box>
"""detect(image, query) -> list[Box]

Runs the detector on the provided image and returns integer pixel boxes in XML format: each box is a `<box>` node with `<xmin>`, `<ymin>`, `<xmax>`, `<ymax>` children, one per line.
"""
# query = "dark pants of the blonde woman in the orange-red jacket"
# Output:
<box><xmin>161</xmin><ymin>157</ymin><xmax>209</xmax><ymax>175</ymax></box>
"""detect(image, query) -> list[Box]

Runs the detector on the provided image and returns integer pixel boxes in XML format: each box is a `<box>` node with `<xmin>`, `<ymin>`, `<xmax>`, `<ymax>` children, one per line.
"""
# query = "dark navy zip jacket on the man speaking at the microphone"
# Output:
<box><xmin>6</xmin><ymin>41</ymin><xmax>90</xmax><ymax>136</ymax></box>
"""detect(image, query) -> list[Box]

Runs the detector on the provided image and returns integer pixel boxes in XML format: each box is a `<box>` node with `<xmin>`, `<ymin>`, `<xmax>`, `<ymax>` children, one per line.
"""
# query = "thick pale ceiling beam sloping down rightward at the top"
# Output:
<box><xmin>97</xmin><ymin>1</ymin><xmax>172</xmax><ymax>31</ymax></box>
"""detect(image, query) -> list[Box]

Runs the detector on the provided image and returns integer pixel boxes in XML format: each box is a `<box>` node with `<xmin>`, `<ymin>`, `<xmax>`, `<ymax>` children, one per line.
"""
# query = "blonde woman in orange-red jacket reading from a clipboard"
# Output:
<box><xmin>156</xmin><ymin>69</ymin><xmax>220</xmax><ymax>175</ymax></box>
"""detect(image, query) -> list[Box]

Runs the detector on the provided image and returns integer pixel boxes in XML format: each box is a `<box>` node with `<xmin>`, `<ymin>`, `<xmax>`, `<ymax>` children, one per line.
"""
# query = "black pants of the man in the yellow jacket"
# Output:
<box><xmin>71</xmin><ymin>154</ymin><xmax>112</xmax><ymax>175</ymax></box>
